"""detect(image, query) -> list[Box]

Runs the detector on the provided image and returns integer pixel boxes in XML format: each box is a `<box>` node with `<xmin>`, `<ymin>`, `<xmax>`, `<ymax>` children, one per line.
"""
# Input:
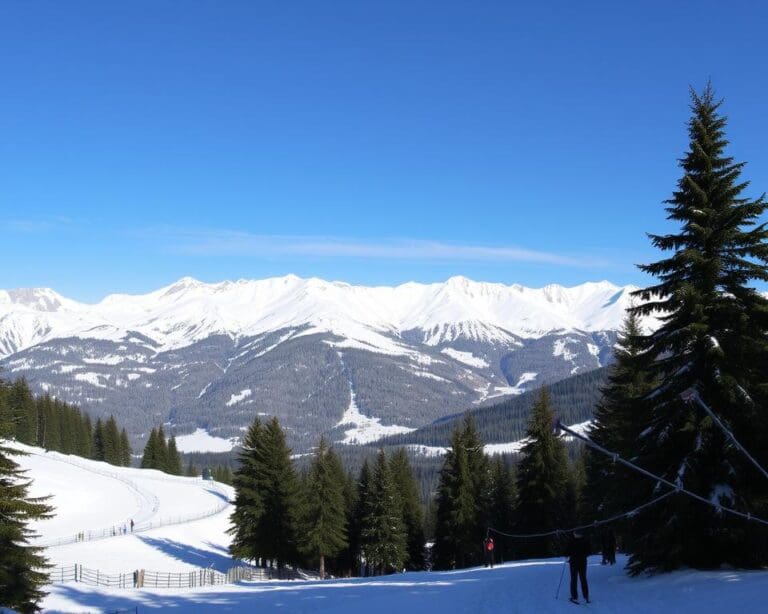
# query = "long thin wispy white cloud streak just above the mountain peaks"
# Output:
<box><xmin>144</xmin><ymin>228</ymin><xmax>605</xmax><ymax>267</ymax></box>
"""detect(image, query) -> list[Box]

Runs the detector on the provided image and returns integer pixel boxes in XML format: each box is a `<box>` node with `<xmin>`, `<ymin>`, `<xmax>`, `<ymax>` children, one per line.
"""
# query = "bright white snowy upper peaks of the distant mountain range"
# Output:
<box><xmin>0</xmin><ymin>275</ymin><xmax>648</xmax><ymax>356</ymax></box>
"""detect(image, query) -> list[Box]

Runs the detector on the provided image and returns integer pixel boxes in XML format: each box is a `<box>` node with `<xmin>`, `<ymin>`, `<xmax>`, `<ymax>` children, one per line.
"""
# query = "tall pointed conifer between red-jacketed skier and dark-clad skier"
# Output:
<box><xmin>515</xmin><ymin>388</ymin><xmax>576</xmax><ymax>558</ymax></box>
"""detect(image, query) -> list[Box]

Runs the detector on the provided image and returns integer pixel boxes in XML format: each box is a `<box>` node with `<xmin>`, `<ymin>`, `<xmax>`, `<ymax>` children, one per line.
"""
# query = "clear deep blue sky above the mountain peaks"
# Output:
<box><xmin>0</xmin><ymin>0</ymin><xmax>768</xmax><ymax>300</ymax></box>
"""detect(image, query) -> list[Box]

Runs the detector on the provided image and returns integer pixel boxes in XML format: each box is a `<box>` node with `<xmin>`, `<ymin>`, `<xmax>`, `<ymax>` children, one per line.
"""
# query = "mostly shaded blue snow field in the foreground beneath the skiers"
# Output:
<box><xmin>43</xmin><ymin>557</ymin><xmax>768</xmax><ymax>614</ymax></box>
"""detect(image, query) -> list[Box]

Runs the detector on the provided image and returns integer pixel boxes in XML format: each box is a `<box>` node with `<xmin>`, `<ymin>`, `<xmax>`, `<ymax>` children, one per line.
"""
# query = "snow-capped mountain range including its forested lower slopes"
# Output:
<box><xmin>0</xmin><ymin>275</ymin><xmax>653</xmax><ymax>448</ymax></box>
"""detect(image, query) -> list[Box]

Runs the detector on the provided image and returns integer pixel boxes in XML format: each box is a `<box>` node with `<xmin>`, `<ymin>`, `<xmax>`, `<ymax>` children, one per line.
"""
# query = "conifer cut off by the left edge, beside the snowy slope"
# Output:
<box><xmin>0</xmin><ymin>418</ymin><xmax>53</xmax><ymax>613</ymax></box>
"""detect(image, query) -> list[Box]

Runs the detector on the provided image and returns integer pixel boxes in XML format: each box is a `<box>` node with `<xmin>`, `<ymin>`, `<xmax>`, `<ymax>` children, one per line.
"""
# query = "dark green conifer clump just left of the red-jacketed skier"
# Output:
<box><xmin>433</xmin><ymin>414</ymin><xmax>489</xmax><ymax>569</ymax></box>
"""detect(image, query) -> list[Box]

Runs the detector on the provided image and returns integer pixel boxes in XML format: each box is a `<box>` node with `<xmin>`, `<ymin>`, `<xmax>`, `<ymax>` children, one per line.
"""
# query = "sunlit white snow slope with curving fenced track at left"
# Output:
<box><xmin>12</xmin><ymin>444</ymin><xmax>233</xmax><ymax>573</ymax></box>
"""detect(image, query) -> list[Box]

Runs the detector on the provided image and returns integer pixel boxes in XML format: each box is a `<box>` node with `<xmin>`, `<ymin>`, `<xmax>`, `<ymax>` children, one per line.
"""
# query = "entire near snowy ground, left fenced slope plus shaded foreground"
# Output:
<box><xmin>13</xmin><ymin>447</ymin><xmax>768</xmax><ymax>614</ymax></box>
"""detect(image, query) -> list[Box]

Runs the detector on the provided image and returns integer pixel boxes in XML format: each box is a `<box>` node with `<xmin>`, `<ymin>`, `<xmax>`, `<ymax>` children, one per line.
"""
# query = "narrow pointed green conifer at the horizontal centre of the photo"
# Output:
<box><xmin>361</xmin><ymin>450</ymin><xmax>407</xmax><ymax>574</ymax></box>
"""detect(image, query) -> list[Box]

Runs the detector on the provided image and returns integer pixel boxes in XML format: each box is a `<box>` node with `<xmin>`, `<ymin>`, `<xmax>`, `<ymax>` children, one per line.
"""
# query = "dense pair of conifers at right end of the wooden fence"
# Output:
<box><xmin>230</xmin><ymin>418</ymin><xmax>298</xmax><ymax>567</ymax></box>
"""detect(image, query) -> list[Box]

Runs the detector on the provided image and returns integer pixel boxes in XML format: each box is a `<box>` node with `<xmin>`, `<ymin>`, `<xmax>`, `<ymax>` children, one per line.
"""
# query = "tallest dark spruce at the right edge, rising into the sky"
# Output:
<box><xmin>630</xmin><ymin>85</ymin><xmax>768</xmax><ymax>573</ymax></box>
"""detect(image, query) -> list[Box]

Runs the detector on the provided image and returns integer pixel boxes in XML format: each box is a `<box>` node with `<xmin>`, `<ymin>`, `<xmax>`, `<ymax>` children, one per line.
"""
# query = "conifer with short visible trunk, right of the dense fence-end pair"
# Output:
<box><xmin>298</xmin><ymin>438</ymin><xmax>347</xmax><ymax>580</ymax></box>
